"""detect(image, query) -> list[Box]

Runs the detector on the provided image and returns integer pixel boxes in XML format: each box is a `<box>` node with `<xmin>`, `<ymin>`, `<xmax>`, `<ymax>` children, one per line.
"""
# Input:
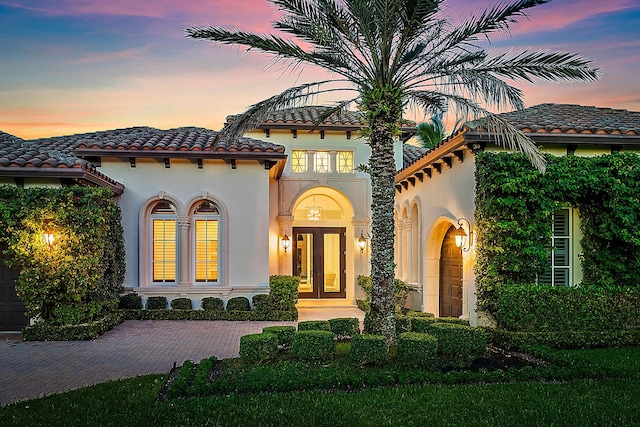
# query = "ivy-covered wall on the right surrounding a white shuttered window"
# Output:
<box><xmin>475</xmin><ymin>152</ymin><xmax>640</xmax><ymax>312</ymax></box>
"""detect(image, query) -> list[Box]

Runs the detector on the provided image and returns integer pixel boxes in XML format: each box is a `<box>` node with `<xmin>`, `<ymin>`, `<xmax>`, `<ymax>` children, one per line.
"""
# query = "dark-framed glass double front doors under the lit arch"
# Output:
<box><xmin>293</xmin><ymin>227</ymin><xmax>346</xmax><ymax>298</ymax></box>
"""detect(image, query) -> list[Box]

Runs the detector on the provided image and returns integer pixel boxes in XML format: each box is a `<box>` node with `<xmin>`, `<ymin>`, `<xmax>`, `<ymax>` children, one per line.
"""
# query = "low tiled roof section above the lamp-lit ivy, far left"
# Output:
<box><xmin>0</xmin><ymin>132</ymin><xmax>124</xmax><ymax>194</ymax></box>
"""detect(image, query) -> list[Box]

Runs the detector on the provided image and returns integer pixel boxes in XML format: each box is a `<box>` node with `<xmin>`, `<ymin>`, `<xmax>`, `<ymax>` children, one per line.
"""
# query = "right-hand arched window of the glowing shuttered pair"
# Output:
<box><xmin>193</xmin><ymin>200</ymin><xmax>220</xmax><ymax>283</ymax></box>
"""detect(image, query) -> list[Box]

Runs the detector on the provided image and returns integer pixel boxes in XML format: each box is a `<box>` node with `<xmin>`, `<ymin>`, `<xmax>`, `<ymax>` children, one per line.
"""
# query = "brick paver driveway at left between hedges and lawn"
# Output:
<box><xmin>0</xmin><ymin>320</ymin><xmax>295</xmax><ymax>405</ymax></box>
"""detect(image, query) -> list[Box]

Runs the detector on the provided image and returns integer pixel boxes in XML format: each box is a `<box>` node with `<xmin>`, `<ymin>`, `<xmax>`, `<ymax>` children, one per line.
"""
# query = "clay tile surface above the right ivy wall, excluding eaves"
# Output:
<box><xmin>467</xmin><ymin>104</ymin><xmax>640</xmax><ymax>135</ymax></box>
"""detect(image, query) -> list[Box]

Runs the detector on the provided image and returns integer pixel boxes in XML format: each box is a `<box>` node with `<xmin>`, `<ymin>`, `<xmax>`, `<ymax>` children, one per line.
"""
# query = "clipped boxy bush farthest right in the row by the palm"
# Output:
<box><xmin>429</xmin><ymin>322</ymin><xmax>487</xmax><ymax>368</ymax></box>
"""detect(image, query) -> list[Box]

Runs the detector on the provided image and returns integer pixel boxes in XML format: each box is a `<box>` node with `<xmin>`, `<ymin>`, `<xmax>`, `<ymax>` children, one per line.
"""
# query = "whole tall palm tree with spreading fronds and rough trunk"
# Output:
<box><xmin>186</xmin><ymin>0</ymin><xmax>598</xmax><ymax>342</ymax></box>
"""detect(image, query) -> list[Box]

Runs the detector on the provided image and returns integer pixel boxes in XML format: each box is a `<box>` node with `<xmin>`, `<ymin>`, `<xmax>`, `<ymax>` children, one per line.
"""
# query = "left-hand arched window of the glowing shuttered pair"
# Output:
<box><xmin>151</xmin><ymin>201</ymin><xmax>178</xmax><ymax>283</ymax></box>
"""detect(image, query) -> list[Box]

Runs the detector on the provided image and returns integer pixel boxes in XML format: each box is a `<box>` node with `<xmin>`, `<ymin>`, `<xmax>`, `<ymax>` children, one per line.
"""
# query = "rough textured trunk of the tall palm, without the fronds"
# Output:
<box><xmin>363</xmin><ymin>86</ymin><xmax>402</xmax><ymax>344</ymax></box>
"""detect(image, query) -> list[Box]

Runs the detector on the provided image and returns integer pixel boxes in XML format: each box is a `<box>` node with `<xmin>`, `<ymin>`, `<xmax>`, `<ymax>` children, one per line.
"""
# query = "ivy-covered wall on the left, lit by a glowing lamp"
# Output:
<box><xmin>0</xmin><ymin>185</ymin><xmax>125</xmax><ymax>324</ymax></box>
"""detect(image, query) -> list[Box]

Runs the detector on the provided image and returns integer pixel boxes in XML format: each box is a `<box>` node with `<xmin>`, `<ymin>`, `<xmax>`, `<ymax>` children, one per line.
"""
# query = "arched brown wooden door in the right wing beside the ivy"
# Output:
<box><xmin>439</xmin><ymin>226</ymin><xmax>462</xmax><ymax>317</ymax></box>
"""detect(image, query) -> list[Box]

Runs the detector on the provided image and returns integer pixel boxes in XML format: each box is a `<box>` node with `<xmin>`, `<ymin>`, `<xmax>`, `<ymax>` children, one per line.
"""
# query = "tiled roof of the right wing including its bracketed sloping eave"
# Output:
<box><xmin>395</xmin><ymin>104</ymin><xmax>640</xmax><ymax>191</ymax></box>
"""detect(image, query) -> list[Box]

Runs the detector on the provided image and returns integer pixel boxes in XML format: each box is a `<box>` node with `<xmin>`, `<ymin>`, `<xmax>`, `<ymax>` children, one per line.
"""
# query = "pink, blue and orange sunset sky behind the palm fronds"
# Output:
<box><xmin>0</xmin><ymin>0</ymin><xmax>640</xmax><ymax>139</ymax></box>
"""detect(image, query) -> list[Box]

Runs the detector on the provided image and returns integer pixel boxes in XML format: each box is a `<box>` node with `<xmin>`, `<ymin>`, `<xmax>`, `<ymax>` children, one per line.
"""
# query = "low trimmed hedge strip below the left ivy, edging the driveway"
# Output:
<box><xmin>22</xmin><ymin>312</ymin><xmax>125</xmax><ymax>341</ymax></box>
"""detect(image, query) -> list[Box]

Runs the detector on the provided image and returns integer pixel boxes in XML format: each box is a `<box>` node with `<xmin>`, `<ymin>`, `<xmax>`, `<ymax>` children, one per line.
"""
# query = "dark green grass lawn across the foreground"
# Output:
<box><xmin>0</xmin><ymin>348</ymin><xmax>640</xmax><ymax>426</ymax></box>
